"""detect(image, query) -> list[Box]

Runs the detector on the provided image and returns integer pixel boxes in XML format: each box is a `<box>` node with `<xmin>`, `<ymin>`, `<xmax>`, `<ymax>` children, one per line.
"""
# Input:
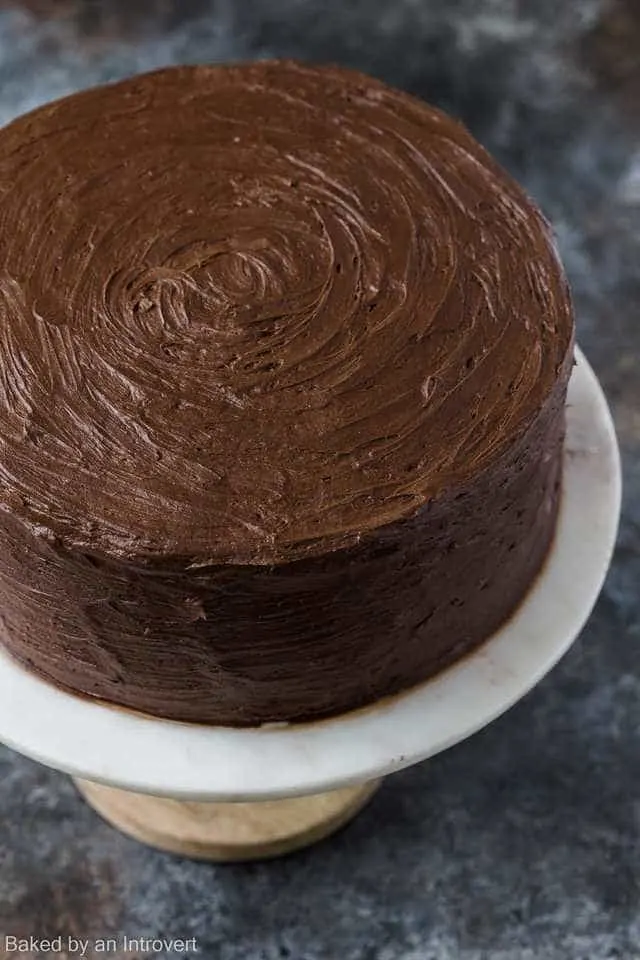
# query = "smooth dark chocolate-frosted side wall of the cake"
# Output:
<box><xmin>0</xmin><ymin>348</ymin><xmax>571</xmax><ymax>726</ymax></box>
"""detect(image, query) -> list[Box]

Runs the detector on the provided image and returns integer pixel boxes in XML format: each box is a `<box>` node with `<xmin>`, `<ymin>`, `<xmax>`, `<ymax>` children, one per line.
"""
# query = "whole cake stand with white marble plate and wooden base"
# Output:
<box><xmin>0</xmin><ymin>353</ymin><xmax>621</xmax><ymax>860</ymax></box>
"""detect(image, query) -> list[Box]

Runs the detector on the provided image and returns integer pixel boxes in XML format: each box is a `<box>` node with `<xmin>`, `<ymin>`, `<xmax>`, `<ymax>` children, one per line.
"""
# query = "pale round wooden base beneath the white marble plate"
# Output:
<box><xmin>75</xmin><ymin>780</ymin><xmax>381</xmax><ymax>862</ymax></box>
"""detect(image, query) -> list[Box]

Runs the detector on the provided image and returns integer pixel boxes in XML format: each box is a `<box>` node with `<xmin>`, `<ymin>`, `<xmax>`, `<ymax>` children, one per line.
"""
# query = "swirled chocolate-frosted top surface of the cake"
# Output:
<box><xmin>0</xmin><ymin>61</ymin><xmax>572</xmax><ymax>564</ymax></box>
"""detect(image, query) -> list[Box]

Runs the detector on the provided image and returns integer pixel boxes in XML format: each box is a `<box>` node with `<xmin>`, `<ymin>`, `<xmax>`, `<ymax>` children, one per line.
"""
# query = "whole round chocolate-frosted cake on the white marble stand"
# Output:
<box><xmin>0</xmin><ymin>62</ymin><xmax>573</xmax><ymax>725</ymax></box>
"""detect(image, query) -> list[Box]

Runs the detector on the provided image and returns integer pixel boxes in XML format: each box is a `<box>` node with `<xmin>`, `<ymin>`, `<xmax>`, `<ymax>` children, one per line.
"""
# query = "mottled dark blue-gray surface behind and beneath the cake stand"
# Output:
<box><xmin>0</xmin><ymin>0</ymin><xmax>640</xmax><ymax>960</ymax></box>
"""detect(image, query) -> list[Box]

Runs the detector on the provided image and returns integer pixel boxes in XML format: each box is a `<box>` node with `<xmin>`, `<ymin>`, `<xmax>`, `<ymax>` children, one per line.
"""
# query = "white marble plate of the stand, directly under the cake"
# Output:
<box><xmin>0</xmin><ymin>353</ymin><xmax>621</xmax><ymax>800</ymax></box>
